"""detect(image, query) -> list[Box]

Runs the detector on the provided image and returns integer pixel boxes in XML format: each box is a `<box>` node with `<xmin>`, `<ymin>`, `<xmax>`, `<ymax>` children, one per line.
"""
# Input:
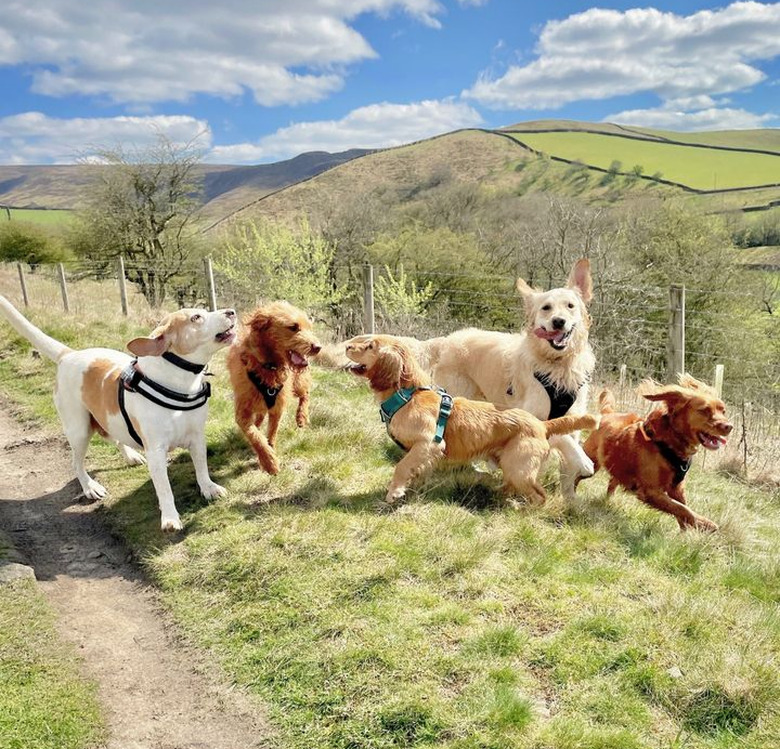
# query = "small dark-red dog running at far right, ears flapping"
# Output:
<box><xmin>584</xmin><ymin>375</ymin><xmax>732</xmax><ymax>531</ymax></box>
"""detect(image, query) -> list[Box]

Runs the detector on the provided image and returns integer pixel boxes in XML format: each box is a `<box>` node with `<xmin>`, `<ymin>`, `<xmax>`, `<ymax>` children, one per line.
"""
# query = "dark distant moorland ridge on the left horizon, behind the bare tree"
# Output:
<box><xmin>0</xmin><ymin>148</ymin><xmax>371</xmax><ymax>213</ymax></box>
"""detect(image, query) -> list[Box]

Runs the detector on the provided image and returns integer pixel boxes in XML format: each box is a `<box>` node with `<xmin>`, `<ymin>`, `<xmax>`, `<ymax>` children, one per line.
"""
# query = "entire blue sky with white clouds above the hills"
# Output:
<box><xmin>0</xmin><ymin>0</ymin><xmax>780</xmax><ymax>164</ymax></box>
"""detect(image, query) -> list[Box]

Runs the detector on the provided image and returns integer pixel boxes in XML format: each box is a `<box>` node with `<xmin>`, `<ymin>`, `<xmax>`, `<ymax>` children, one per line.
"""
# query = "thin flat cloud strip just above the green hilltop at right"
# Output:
<box><xmin>604</xmin><ymin>107</ymin><xmax>778</xmax><ymax>131</ymax></box>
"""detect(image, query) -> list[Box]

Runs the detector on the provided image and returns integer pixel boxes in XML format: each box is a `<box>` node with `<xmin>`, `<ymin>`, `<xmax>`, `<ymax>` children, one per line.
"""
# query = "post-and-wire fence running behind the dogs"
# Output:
<box><xmin>0</xmin><ymin>259</ymin><xmax>780</xmax><ymax>480</ymax></box>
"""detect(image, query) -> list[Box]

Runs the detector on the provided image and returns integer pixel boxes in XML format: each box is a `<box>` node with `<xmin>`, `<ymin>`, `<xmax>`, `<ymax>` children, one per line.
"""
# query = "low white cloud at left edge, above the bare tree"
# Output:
<box><xmin>0</xmin><ymin>112</ymin><xmax>211</xmax><ymax>164</ymax></box>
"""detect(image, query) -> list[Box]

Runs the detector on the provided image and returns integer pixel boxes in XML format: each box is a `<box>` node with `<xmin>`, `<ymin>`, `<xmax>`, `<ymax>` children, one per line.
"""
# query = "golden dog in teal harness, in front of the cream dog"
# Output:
<box><xmin>346</xmin><ymin>335</ymin><xmax>597</xmax><ymax>502</ymax></box>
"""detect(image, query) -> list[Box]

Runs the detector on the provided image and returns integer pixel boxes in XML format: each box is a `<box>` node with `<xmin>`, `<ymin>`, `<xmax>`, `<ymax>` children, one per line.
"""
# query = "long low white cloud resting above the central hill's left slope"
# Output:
<box><xmin>208</xmin><ymin>99</ymin><xmax>482</xmax><ymax>164</ymax></box>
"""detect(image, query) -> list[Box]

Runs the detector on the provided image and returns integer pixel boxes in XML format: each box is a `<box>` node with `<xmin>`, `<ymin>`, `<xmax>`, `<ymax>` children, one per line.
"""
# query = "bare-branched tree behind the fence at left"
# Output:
<box><xmin>71</xmin><ymin>133</ymin><xmax>207</xmax><ymax>307</ymax></box>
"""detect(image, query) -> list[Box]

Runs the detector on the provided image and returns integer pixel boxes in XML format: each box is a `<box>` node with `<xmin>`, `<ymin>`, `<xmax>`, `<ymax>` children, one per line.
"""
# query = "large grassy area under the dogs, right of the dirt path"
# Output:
<box><xmin>0</xmin><ymin>306</ymin><xmax>780</xmax><ymax>749</ymax></box>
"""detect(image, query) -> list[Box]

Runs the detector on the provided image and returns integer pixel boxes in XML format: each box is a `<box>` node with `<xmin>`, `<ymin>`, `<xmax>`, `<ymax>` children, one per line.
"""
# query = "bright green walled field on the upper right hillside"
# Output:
<box><xmin>516</xmin><ymin>132</ymin><xmax>780</xmax><ymax>190</ymax></box>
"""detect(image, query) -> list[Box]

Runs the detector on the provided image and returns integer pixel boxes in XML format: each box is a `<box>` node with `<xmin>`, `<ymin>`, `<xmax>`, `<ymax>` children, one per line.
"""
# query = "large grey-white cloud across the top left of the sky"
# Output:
<box><xmin>0</xmin><ymin>0</ymin><xmax>444</xmax><ymax>106</ymax></box>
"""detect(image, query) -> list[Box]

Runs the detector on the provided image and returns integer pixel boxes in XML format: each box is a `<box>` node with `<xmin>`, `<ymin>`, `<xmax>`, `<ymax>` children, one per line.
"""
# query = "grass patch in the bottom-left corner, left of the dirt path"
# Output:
<box><xmin>0</xmin><ymin>581</ymin><xmax>104</xmax><ymax>749</ymax></box>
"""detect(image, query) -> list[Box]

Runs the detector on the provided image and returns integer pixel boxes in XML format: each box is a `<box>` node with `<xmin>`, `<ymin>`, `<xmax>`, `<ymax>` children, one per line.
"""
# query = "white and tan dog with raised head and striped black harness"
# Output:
<box><xmin>0</xmin><ymin>296</ymin><xmax>236</xmax><ymax>531</ymax></box>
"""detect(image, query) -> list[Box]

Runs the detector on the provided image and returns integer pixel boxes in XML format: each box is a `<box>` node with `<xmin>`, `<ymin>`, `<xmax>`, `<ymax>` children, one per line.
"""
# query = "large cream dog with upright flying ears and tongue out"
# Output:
<box><xmin>424</xmin><ymin>259</ymin><xmax>596</xmax><ymax>498</ymax></box>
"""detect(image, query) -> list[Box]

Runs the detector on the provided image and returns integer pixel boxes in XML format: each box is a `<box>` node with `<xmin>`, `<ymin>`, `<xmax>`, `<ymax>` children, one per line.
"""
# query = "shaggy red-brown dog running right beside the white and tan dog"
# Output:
<box><xmin>227</xmin><ymin>302</ymin><xmax>321</xmax><ymax>474</ymax></box>
